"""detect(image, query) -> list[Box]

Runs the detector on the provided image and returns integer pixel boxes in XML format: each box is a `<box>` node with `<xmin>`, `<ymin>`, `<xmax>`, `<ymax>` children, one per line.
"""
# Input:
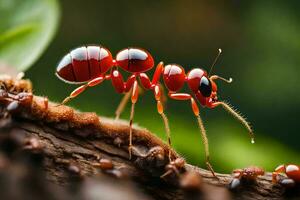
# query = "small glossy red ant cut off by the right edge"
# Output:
<box><xmin>272</xmin><ymin>164</ymin><xmax>300</xmax><ymax>187</ymax></box>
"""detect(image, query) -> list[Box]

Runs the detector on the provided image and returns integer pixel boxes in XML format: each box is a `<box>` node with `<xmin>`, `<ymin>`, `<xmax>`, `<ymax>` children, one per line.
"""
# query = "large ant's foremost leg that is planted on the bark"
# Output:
<box><xmin>169</xmin><ymin>93</ymin><xmax>217</xmax><ymax>177</ymax></box>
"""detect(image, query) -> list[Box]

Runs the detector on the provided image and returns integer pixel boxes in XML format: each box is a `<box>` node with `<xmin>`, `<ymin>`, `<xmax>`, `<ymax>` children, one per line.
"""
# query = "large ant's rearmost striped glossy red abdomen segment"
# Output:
<box><xmin>56</xmin><ymin>46</ymin><xmax>113</xmax><ymax>83</ymax></box>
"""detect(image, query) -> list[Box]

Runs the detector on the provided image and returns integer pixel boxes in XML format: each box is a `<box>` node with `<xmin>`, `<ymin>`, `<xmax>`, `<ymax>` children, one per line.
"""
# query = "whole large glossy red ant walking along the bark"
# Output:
<box><xmin>56</xmin><ymin>46</ymin><xmax>254</xmax><ymax>176</ymax></box>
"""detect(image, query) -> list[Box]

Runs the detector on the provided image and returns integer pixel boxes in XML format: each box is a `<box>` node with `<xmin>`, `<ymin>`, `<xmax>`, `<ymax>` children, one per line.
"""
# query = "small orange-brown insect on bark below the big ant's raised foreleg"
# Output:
<box><xmin>229</xmin><ymin>166</ymin><xmax>265</xmax><ymax>189</ymax></box>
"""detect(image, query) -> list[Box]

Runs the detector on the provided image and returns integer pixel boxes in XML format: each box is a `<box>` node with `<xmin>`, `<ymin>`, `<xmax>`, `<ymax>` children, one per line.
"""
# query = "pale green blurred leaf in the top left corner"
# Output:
<box><xmin>0</xmin><ymin>0</ymin><xmax>59</xmax><ymax>71</ymax></box>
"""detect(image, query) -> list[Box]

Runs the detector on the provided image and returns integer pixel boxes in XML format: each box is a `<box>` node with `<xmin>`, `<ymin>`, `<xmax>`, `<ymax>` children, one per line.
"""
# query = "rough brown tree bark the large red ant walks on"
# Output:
<box><xmin>0</xmin><ymin>77</ymin><xmax>300</xmax><ymax>199</ymax></box>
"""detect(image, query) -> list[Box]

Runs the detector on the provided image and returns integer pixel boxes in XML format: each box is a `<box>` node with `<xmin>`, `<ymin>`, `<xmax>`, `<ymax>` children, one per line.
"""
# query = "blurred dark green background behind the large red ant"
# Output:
<box><xmin>0</xmin><ymin>0</ymin><xmax>300</xmax><ymax>172</ymax></box>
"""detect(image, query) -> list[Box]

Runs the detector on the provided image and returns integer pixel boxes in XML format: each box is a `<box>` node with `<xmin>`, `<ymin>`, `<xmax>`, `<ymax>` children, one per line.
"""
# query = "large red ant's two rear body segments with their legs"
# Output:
<box><xmin>56</xmin><ymin>46</ymin><xmax>171</xmax><ymax>160</ymax></box>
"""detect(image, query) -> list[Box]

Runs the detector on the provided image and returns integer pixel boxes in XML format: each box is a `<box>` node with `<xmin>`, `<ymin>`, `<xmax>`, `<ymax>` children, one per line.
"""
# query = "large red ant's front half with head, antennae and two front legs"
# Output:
<box><xmin>156</xmin><ymin>49</ymin><xmax>254</xmax><ymax>176</ymax></box>
